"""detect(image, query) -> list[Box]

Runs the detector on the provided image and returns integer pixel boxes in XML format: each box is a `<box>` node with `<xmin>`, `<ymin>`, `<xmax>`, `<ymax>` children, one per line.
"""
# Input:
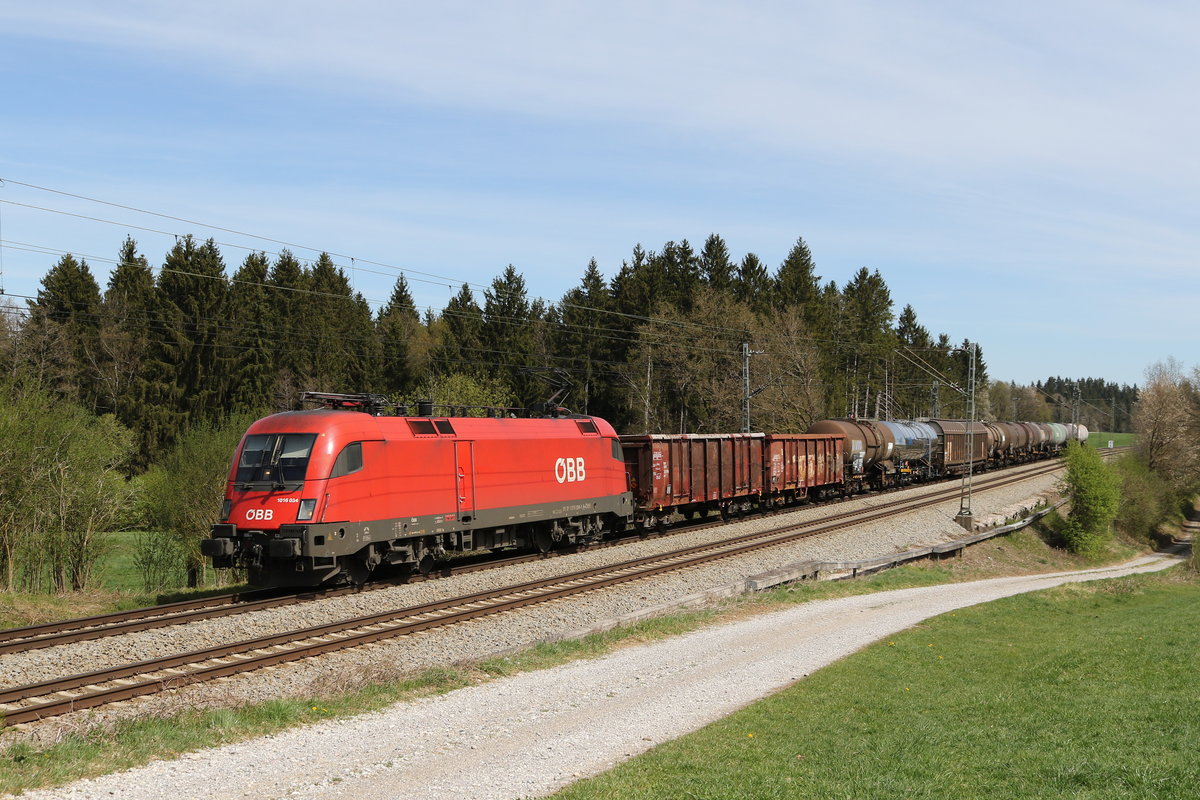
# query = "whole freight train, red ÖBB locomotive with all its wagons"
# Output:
<box><xmin>200</xmin><ymin>392</ymin><xmax>1087</xmax><ymax>587</ymax></box>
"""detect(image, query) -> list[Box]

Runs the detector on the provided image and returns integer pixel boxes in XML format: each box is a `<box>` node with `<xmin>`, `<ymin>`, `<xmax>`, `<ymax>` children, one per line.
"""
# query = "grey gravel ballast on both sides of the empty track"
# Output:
<box><xmin>0</xmin><ymin>475</ymin><xmax>1058</xmax><ymax>744</ymax></box>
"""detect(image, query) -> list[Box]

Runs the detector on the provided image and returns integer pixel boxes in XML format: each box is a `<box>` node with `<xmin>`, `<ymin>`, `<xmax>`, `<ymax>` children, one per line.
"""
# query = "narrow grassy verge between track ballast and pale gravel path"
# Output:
<box><xmin>0</xmin><ymin>522</ymin><xmax>1180</xmax><ymax>793</ymax></box>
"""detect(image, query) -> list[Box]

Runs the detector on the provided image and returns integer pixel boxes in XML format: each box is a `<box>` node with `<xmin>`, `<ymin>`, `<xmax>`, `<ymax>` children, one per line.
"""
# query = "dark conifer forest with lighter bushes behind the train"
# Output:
<box><xmin>0</xmin><ymin>234</ymin><xmax>1136</xmax><ymax>589</ymax></box>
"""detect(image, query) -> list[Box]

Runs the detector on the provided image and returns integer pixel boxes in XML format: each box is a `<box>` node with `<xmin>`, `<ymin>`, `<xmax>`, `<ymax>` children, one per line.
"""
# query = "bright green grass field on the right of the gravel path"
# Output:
<box><xmin>556</xmin><ymin>567</ymin><xmax>1200</xmax><ymax>800</ymax></box>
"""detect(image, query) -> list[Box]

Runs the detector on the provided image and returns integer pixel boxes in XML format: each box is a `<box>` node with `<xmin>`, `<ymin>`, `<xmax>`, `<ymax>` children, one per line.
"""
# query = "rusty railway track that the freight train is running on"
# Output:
<box><xmin>0</xmin><ymin>453</ymin><xmax>1070</xmax><ymax>655</ymax></box>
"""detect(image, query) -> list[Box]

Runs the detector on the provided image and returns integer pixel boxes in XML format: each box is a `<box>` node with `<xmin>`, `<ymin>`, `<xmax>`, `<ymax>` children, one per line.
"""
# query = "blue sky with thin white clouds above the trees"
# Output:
<box><xmin>0</xmin><ymin>0</ymin><xmax>1200</xmax><ymax>383</ymax></box>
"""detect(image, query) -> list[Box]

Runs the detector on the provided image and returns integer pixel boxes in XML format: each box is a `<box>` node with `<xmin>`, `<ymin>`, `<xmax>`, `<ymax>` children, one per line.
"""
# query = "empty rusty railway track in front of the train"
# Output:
<box><xmin>0</xmin><ymin>455</ymin><xmax>1060</xmax><ymax>726</ymax></box>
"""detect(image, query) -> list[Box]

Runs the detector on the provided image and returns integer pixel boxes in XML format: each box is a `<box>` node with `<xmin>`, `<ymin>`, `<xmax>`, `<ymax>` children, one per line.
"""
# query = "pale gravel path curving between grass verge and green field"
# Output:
<box><xmin>14</xmin><ymin>555</ymin><xmax>1180</xmax><ymax>800</ymax></box>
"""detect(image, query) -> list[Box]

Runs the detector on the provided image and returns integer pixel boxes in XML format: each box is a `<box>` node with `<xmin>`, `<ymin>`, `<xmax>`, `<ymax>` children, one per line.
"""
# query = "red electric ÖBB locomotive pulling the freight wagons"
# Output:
<box><xmin>202</xmin><ymin>393</ymin><xmax>634</xmax><ymax>585</ymax></box>
